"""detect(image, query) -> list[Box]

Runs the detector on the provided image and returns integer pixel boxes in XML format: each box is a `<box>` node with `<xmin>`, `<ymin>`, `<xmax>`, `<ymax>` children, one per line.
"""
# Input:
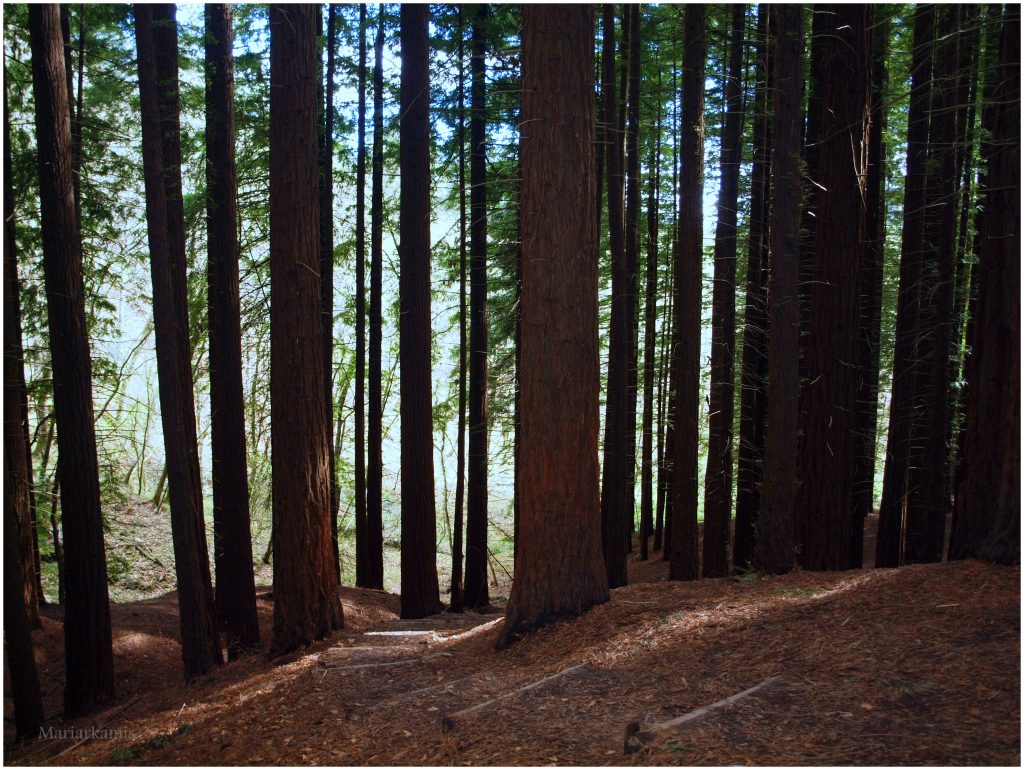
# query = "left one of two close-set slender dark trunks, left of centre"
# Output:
<box><xmin>352</xmin><ymin>4</ymin><xmax>368</xmax><ymax>587</ymax></box>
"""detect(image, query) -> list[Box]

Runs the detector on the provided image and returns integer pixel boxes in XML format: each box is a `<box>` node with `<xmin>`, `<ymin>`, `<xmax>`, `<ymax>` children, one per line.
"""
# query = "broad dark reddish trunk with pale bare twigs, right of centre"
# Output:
<box><xmin>790</xmin><ymin>5</ymin><xmax>873</xmax><ymax>569</ymax></box>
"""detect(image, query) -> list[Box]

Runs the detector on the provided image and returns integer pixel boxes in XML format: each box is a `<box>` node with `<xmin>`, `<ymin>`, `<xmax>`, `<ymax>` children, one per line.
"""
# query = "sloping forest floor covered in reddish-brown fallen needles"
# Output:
<box><xmin>4</xmin><ymin>544</ymin><xmax>1021</xmax><ymax>766</ymax></box>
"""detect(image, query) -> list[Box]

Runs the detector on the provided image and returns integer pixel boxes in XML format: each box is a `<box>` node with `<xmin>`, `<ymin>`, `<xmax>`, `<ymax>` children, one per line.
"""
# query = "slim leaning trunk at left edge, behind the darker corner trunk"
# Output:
<box><xmin>3</xmin><ymin>68</ymin><xmax>42</xmax><ymax>629</ymax></box>
